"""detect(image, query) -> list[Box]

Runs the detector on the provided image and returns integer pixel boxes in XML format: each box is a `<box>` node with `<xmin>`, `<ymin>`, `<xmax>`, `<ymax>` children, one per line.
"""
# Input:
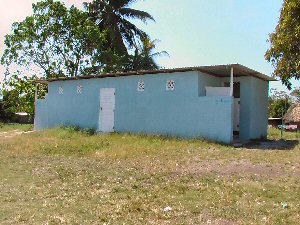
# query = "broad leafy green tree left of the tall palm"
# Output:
<box><xmin>1</xmin><ymin>0</ymin><xmax>105</xmax><ymax>78</ymax></box>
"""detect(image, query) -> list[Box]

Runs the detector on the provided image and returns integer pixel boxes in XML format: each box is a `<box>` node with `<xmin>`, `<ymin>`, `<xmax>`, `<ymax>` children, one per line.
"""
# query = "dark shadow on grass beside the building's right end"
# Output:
<box><xmin>242</xmin><ymin>139</ymin><xmax>299</xmax><ymax>150</ymax></box>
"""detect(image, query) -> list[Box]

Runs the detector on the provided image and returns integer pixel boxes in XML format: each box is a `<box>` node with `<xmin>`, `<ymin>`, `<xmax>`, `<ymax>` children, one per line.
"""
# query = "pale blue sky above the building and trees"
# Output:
<box><xmin>0</xmin><ymin>0</ymin><xmax>300</xmax><ymax>90</ymax></box>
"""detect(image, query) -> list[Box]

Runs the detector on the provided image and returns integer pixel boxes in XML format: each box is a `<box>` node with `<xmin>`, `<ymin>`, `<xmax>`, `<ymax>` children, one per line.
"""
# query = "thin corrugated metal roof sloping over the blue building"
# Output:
<box><xmin>37</xmin><ymin>64</ymin><xmax>276</xmax><ymax>83</ymax></box>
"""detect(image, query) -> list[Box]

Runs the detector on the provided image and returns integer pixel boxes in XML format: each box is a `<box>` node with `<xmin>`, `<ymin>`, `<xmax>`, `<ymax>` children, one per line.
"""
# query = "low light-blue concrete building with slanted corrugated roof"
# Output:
<box><xmin>34</xmin><ymin>64</ymin><xmax>274</xmax><ymax>143</ymax></box>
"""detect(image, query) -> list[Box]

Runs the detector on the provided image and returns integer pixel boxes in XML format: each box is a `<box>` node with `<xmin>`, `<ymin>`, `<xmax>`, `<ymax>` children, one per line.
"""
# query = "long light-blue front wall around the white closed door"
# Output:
<box><xmin>35</xmin><ymin>71</ymin><xmax>233</xmax><ymax>143</ymax></box>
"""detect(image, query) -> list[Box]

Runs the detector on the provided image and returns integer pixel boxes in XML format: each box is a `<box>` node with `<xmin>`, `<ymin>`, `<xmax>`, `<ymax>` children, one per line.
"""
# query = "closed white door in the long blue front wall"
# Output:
<box><xmin>99</xmin><ymin>88</ymin><xmax>115</xmax><ymax>132</ymax></box>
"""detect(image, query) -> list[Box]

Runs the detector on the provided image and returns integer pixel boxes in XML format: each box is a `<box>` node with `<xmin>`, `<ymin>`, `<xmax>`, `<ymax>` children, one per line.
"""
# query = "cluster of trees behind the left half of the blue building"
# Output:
<box><xmin>1</xmin><ymin>0</ymin><xmax>162</xmax><ymax>121</ymax></box>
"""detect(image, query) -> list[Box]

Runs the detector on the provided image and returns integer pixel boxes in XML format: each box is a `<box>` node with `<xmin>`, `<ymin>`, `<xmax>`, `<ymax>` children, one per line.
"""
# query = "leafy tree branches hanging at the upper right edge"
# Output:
<box><xmin>265</xmin><ymin>0</ymin><xmax>300</xmax><ymax>89</ymax></box>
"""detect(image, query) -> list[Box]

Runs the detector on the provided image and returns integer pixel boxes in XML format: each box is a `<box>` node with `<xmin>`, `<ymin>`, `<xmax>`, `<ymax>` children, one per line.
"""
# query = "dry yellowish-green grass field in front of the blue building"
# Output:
<box><xmin>0</xmin><ymin>125</ymin><xmax>300</xmax><ymax>224</ymax></box>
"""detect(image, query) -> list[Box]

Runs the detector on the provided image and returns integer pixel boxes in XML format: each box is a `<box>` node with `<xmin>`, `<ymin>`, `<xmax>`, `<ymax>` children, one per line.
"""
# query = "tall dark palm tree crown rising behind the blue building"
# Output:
<box><xmin>84</xmin><ymin>0</ymin><xmax>154</xmax><ymax>55</ymax></box>
